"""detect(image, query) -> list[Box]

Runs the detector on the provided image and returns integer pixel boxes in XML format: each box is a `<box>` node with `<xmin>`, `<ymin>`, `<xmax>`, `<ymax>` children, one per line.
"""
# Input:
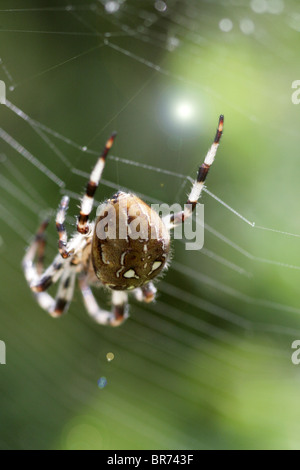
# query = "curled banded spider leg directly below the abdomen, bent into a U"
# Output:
<box><xmin>79</xmin><ymin>276</ymin><xmax>129</xmax><ymax>326</ymax></box>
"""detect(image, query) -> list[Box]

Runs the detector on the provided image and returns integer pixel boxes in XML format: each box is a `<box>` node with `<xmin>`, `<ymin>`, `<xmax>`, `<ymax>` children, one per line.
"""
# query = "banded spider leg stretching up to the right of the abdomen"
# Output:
<box><xmin>163</xmin><ymin>115</ymin><xmax>224</xmax><ymax>230</ymax></box>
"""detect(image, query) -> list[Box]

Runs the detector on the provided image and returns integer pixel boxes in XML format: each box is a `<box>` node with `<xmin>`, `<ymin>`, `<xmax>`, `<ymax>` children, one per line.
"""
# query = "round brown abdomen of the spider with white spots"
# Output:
<box><xmin>92</xmin><ymin>192</ymin><xmax>170</xmax><ymax>290</ymax></box>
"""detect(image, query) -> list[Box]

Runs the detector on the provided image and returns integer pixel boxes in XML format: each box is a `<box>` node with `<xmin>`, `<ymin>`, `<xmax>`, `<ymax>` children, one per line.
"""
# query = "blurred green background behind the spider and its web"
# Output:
<box><xmin>0</xmin><ymin>0</ymin><xmax>300</xmax><ymax>449</ymax></box>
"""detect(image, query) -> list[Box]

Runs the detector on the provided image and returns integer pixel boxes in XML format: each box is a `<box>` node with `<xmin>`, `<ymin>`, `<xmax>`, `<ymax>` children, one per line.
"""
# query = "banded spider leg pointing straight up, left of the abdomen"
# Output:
<box><xmin>77</xmin><ymin>132</ymin><xmax>117</xmax><ymax>234</ymax></box>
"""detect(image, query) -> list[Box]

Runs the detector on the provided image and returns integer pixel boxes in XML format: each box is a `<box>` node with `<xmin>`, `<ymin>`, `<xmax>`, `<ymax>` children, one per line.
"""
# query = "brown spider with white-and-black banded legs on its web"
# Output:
<box><xmin>23</xmin><ymin>115</ymin><xmax>224</xmax><ymax>326</ymax></box>
